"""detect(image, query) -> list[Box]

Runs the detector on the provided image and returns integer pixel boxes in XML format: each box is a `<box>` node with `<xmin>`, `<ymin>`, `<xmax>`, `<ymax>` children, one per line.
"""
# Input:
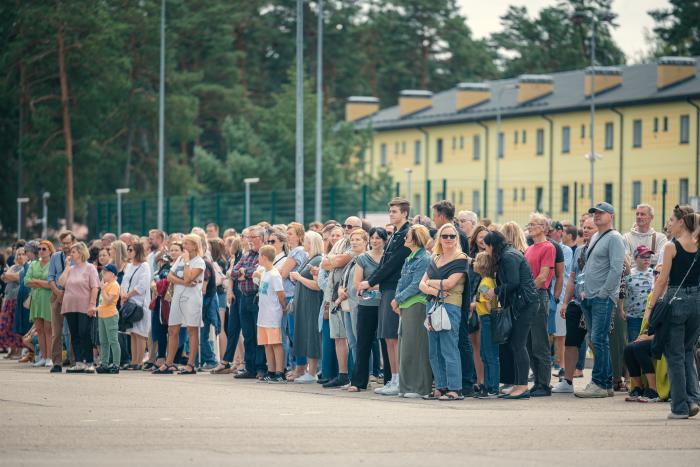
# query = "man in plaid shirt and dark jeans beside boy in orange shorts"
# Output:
<box><xmin>231</xmin><ymin>227</ymin><xmax>267</xmax><ymax>379</ymax></box>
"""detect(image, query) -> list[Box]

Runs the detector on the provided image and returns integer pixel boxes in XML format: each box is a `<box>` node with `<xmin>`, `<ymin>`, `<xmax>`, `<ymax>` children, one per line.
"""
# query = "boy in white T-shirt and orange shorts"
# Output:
<box><xmin>258</xmin><ymin>245</ymin><xmax>287</xmax><ymax>383</ymax></box>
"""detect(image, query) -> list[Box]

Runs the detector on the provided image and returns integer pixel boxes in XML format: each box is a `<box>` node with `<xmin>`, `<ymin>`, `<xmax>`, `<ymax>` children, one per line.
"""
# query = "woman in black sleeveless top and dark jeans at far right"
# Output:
<box><xmin>649</xmin><ymin>206</ymin><xmax>700</xmax><ymax>419</ymax></box>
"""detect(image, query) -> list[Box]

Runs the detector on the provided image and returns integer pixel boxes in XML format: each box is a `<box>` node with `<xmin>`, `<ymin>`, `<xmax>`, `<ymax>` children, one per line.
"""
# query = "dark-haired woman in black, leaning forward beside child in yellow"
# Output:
<box><xmin>484</xmin><ymin>232</ymin><xmax>539</xmax><ymax>399</ymax></box>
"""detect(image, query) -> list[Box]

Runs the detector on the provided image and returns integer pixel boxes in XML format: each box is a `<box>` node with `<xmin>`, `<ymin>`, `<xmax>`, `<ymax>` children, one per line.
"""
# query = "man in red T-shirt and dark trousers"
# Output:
<box><xmin>525</xmin><ymin>213</ymin><xmax>556</xmax><ymax>397</ymax></box>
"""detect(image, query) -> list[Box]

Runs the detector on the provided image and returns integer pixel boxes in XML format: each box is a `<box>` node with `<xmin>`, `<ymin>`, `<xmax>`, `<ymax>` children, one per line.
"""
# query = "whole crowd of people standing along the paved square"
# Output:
<box><xmin>0</xmin><ymin>198</ymin><xmax>700</xmax><ymax>419</ymax></box>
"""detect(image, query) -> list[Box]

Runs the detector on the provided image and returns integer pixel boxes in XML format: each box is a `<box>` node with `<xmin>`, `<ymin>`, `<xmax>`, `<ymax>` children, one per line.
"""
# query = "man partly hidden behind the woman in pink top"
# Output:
<box><xmin>48</xmin><ymin>230</ymin><xmax>75</xmax><ymax>373</ymax></box>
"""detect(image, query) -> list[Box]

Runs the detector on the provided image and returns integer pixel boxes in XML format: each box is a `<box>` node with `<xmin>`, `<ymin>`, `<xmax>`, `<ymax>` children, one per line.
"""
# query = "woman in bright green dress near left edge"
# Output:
<box><xmin>24</xmin><ymin>240</ymin><xmax>54</xmax><ymax>367</ymax></box>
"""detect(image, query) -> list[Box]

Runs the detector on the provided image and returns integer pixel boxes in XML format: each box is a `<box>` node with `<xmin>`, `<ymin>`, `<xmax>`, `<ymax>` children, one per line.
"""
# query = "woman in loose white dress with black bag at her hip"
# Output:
<box><xmin>121</xmin><ymin>242</ymin><xmax>152</xmax><ymax>370</ymax></box>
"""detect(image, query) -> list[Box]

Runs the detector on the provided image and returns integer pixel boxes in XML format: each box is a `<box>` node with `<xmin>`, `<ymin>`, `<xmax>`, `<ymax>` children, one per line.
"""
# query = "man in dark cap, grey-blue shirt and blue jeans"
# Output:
<box><xmin>575</xmin><ymin>203</ymin><xmax>625</xmax><ymax>398</ymax></box>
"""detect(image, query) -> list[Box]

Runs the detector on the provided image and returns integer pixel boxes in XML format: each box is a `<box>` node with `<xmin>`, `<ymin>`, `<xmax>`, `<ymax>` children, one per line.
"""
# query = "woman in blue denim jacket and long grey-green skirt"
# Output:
<box><xmin>391</xmin><ymin>224</ymin><xmax>433</xmax><ymax>398</ymax></box>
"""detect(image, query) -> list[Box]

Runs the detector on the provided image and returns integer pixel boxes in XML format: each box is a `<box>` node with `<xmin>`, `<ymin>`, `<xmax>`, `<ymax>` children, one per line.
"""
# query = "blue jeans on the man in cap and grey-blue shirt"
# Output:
<box><xmin>581</xmin><ymin>298</ymin><xmax>615</xmax><ymax>389</ymax></box>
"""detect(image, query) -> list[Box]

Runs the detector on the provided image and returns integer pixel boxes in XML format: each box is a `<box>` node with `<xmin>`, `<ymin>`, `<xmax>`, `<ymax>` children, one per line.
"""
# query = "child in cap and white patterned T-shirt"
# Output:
<box><xmin>625</xmin><ymin>245</ymin><xmax>654</xmax><ymax>342</ymax></box>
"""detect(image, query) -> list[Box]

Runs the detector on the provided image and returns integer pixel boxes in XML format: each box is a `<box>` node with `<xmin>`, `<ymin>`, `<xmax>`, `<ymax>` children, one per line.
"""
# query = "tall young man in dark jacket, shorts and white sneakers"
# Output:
<box><xmin>358</xmin><ymin>198</ymin><xmax>411</xmax><ymax>395</ymax></box>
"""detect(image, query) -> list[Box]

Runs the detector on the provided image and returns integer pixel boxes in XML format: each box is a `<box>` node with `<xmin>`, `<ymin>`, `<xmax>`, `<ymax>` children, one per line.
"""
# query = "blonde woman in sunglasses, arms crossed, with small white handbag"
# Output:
<box><xmin>419</xmin><ymin>223</ymin><xmax>467</xmax><ymax>400</ymax></box>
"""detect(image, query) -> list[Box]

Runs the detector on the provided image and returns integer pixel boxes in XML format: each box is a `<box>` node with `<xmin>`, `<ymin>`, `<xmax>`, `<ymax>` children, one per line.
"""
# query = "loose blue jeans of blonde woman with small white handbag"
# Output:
<box><xmin>428</xmin><ymin>303</ymin><xmax>464</xmax><ymax>391</ymax></box>
